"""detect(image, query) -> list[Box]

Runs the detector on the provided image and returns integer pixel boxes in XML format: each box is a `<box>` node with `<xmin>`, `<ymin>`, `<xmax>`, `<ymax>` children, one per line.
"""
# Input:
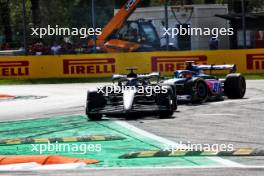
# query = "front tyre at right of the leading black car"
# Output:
<box><xmin>157</xmin><ymin>86</ymin><xmax>175</xmax><ymax>118</ymax></box>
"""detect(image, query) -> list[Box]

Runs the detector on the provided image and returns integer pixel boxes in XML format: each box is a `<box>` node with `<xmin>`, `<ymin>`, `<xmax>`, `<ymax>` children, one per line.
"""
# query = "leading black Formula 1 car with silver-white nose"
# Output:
<box><xmin>86</xmin><ymin>69</ymin><xmax>177</xmax><ymax>120</ymax></box>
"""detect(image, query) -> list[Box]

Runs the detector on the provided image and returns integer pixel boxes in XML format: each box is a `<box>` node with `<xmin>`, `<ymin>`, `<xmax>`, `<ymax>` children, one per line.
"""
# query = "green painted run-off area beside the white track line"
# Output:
<box><xmin>0</xmin><ymin>115</ymin><xmax>219</xmax><ymax>167</ymax></box>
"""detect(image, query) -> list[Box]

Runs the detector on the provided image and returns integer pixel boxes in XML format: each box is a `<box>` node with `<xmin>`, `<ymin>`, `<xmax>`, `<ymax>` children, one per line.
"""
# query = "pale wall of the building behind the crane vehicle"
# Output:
<box><xmin>125</xmin><ymin>4</ymin><xmax>229</xmax><ymax>50</ymax></box>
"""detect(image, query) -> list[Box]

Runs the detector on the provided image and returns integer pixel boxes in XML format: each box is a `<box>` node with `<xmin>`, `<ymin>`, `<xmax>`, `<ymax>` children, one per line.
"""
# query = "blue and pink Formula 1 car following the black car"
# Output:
<box><xmin>164</xmin><ymin>61</ymin><xmax>246</xmax><ymax>103</ymax></box>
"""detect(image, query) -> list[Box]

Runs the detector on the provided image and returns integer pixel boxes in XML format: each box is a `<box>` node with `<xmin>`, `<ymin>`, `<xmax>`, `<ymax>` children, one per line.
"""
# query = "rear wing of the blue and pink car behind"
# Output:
<box><xmin>195</xmin><ymin>64</ymin><xmax>237</xmax><ymax>73</ymax></box>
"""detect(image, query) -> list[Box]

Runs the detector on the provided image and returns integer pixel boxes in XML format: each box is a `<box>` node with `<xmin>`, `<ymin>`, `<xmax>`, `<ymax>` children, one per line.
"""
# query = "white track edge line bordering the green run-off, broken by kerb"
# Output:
<box><xmin>115</xmin><ymin>121</ymin><xmax>244</xmax><ymax>167</ymax></box>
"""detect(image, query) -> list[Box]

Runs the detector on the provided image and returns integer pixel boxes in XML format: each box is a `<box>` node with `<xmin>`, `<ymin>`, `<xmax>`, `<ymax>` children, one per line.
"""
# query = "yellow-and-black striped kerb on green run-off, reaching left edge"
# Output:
<box><xmin>0</xmin><ymin>135</ymin><xmax>126</xmax><ymax>145</ymax></box>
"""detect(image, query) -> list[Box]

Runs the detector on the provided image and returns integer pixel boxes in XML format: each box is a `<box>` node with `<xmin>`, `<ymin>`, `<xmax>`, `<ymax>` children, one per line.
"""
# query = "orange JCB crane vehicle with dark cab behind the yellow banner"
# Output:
<box><xmin>88</xmin><ymin>0</ymin><xmax>160</xmax><ymax>52</ymax></box>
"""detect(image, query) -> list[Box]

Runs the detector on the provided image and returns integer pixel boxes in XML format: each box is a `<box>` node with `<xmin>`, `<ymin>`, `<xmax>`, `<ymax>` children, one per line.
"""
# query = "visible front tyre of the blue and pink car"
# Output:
<box><xmin>192</xmin><ymin>79</ymin><xmax>209</xmax><ymax>103</ymax></box>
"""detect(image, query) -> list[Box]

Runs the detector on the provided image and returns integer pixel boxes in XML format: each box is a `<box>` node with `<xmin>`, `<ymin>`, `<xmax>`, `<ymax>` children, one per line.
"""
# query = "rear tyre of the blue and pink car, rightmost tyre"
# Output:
<box><xmin>224</xmin><ymin>74</ymin><xmax>246</xmax><ymax>99</ymax></box>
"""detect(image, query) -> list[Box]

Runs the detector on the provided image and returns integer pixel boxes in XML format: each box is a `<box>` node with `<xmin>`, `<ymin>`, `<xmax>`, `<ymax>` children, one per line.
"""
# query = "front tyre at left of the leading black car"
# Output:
<box><xmin>86</xmin><ymin>91</ymin><xmax>106</xmax><ymax>121</ymax></box>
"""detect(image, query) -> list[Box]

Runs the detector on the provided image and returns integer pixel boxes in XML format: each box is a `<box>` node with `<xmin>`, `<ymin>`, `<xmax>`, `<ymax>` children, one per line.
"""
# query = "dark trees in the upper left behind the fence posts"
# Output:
<box><xmin>0</xmin><ymin>0</ymin><xmax>114</xmax><ymax>45</ymax></box>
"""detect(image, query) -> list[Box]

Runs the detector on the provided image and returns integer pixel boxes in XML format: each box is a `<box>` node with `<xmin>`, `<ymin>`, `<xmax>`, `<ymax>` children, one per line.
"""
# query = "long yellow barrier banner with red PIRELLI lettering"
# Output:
<box><xmin>0</xmin><ymin>49</ymin><xmax>264</xmax><ymax>79</ymax></box>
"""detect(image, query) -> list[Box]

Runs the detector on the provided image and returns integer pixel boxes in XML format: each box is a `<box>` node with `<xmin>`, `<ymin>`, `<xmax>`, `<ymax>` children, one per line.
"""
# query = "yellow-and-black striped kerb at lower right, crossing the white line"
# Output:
<box><xmin>119</xmin><ymin>148</ymin><xmax>264</xmax><ymax>159</ymax></box>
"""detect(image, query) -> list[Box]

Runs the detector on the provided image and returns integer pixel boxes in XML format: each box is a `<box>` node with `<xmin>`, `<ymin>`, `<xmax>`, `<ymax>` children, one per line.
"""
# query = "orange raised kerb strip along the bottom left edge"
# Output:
<box><xmin>0</xmin><ymin>155</ymin><xmax>100</xmax><ymax>165</ymax></box>
